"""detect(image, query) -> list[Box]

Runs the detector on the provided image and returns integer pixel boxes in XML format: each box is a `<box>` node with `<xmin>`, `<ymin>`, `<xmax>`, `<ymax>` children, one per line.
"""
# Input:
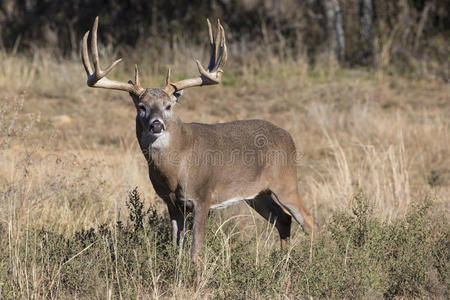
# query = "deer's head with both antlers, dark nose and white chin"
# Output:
<box><xmin>82</xmin><ymin>17</ymin><xmax>227</xmax><ymax>138</ymax></box>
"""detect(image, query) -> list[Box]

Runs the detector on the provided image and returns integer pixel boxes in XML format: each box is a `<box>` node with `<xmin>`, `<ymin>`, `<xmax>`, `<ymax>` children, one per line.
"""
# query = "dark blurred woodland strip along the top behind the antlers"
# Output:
<box><xmin>0</xmin><ymin>0</ymin><xmax>450</xmax><ymax>75</ymax></box>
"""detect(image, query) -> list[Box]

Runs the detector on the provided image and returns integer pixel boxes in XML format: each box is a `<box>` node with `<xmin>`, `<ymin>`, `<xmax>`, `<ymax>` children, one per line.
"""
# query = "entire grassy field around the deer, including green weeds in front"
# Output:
<box><xmin>0</xmin><ymin>49</ymin><xmax>450</xmax><ymax>299</ymax></box>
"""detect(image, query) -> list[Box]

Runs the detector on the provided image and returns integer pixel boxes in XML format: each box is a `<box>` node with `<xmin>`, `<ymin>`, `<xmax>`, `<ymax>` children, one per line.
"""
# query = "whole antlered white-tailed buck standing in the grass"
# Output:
<box><xmin>82</xmin><ymin>17</ymin><xmax>314</xmax><ymax>264</ymax></box>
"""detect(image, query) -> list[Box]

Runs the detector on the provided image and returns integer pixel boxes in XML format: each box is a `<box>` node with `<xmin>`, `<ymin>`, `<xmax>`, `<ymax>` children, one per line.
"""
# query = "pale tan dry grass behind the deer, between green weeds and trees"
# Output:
<box><xmin>0</xmin><ymin>51</ymin><xmax>450</xmax><ymax>298</ymax></box>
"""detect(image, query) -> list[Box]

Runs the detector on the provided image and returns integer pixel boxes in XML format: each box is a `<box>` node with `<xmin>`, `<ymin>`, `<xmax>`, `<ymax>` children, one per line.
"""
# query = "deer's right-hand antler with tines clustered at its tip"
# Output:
<box><xmin>164</xmin><ymin>19</ymin><xmax>227</xmax><ymax>95</ymax></box>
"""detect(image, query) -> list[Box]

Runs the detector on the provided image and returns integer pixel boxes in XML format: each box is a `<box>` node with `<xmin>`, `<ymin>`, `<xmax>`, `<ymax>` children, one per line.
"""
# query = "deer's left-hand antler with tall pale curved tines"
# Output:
<box><xmin>82</xmin><ymin>17</ymin><xmax>145</xmax><ymax>96</ymax></box>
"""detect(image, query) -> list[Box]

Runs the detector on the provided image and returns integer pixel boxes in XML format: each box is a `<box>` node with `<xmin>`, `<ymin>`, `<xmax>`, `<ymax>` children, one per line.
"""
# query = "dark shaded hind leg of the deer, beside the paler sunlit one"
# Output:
<box><xmin>245</xmin><ymin>192</ymin><xmax>292</xmax><ymax>249</ymax></box>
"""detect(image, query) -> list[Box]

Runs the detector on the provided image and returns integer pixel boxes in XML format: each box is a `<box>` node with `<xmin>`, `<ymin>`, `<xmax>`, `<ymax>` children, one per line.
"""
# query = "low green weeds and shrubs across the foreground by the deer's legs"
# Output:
<box><xmin>0</xmin><ymin>189</ymin><xmax>450</xmax><ymax>299</ymax></box>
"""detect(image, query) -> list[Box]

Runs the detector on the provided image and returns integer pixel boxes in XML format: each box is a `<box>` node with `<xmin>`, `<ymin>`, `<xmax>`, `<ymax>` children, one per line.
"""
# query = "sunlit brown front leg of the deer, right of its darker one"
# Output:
<box><xmin>191</xmin><ymin>201</ymin><xmax>209</xmax><ymax>267</ymax></box>
